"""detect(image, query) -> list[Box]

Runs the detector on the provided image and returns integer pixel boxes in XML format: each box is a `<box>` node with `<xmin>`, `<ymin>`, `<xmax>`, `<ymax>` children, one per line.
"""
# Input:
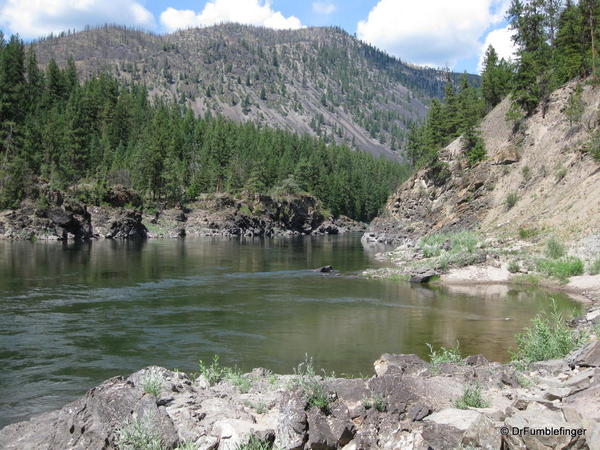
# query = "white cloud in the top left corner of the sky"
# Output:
<box><xmin>0</xmin><ymin>0</ymin><xmax>154</xmax><ymax>38</ymax></box>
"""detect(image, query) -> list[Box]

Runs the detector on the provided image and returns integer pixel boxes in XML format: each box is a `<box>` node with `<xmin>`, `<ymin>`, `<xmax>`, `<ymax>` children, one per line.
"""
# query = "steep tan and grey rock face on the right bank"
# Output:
<box><xmin>365</xmin><ymin>79</ymin><xmax>600</xmax><ymax>243</ymax></box>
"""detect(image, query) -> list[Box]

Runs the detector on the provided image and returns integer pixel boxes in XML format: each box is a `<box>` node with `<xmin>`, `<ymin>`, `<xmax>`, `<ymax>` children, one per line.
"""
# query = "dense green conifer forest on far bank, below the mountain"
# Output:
<box><xmin>0</xmin><ymin>32</ymin><xmax>409</xmax><ymax>220</ymax></box>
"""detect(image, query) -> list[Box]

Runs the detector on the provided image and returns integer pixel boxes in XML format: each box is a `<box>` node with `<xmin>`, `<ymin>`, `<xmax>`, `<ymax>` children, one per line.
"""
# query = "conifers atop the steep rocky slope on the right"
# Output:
<box><xmin>407</xmin><ymin>0</ymin><xmax>600</xmax><ymax>169</ymax></box>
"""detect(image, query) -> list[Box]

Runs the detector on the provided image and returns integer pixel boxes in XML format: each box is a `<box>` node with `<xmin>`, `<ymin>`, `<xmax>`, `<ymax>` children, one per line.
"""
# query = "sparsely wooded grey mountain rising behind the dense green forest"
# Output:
<box><xmin>32</xmin><ymin>24</ymin><xmax>479</xmax><ymax>159</ymax></box>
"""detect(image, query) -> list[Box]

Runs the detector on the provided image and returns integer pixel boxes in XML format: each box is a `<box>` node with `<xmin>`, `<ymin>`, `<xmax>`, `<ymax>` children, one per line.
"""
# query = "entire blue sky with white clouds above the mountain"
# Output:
<box><xmin>0</xmin><ymin>0</ymin><xmax>513</xmax><ymax>73</ymax></box>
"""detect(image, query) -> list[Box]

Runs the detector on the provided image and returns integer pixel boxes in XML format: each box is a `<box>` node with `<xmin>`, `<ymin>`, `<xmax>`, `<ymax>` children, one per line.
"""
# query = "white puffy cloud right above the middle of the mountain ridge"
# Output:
<box><xmin>160</xmin><ymin>0</ymin><xmax>302</xmax><ymax>31</ymax></box>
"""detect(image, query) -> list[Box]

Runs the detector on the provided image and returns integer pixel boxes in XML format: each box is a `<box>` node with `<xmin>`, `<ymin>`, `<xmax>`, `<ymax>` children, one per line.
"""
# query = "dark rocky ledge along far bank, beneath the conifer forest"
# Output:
<box><xmin>0</xmin><ymin>187</ymin><xmax>366</xmax><ymax>240</ymax></box>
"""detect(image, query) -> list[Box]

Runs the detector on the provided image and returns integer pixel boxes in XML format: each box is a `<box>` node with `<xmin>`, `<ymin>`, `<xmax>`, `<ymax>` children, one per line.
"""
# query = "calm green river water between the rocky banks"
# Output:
<box><xmin>0</xmin><ymin>236</ymin><xmax>576</xmax><ymax>426</ymax></box>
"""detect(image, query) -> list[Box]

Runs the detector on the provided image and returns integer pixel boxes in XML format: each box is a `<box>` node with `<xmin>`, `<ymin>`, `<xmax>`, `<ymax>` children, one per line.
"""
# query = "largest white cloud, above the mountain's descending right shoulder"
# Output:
<box><xmin>357</xmin><ymin>0</ymin><xmax>509</xmax><ymax>67</ymax></box>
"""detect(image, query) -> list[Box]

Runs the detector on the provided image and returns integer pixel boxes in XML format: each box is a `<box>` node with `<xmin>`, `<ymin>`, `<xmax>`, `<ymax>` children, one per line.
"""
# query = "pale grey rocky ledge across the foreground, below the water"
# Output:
<box><xmin>0</xmin><ymin>341</ymin><xmax>600</xmax><ymax>450</ymax></box>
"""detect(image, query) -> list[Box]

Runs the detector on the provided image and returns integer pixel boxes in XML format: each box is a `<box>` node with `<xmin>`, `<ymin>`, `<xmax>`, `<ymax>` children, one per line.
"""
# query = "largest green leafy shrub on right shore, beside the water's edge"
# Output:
<box><xmin>512</xmin><ymin>300</ymin><xmax>583</xmax><ymax>365</ymax></box>
